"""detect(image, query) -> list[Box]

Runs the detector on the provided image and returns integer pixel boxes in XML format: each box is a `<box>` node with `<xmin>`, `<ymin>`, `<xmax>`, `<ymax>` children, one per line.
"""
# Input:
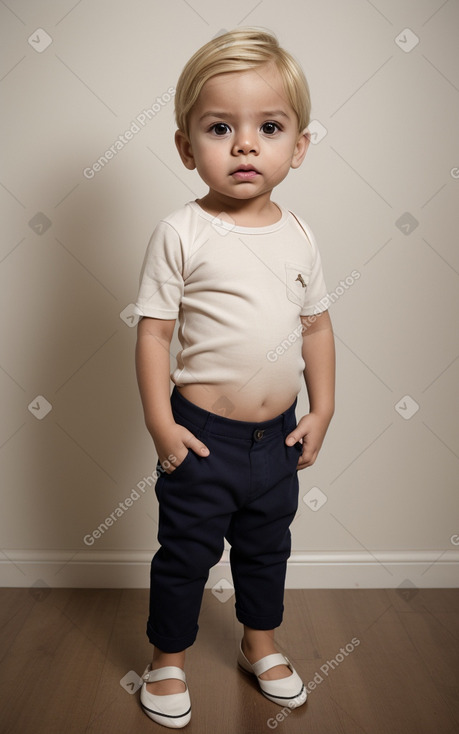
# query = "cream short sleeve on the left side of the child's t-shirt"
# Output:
<box><xmin>134</xmin><ymin>221</ymin><xmax>183</xmax><ymax>319</ymax></box>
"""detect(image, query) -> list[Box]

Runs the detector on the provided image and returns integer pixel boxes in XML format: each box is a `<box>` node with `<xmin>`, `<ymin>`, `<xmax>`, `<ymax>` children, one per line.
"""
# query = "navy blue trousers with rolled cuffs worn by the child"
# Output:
<box><xmin>147</xmin><ymin>388</ymin><xmax>302</xmax><ymax>653</ymax></box>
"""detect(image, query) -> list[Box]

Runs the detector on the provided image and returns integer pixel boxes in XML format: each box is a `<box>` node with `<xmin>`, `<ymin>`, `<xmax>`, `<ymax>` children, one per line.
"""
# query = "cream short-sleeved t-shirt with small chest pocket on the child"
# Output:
<box><xmin>135</xmin><ymin>201</ymin><xmax>327</xmax><ymax>397</ymax></box>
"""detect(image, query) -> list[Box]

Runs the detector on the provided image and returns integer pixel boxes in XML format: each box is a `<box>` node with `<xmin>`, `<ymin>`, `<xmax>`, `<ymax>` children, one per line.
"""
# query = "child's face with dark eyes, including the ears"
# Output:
<box><xmin>176</xmin><ymin>64</ymin><xmax>309</xmax><ymax>207</ymax></box>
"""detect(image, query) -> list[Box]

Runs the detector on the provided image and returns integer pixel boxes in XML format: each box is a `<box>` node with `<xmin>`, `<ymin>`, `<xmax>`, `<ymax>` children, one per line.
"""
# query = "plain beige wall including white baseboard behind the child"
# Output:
<box><xmin>0</xmin><ymin>0</ymin><xmax>459</xmax><ymax>587</ymax></box>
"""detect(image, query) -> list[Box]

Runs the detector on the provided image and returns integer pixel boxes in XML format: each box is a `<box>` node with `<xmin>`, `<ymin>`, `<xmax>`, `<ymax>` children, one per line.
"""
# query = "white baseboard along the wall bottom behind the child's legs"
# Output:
<box><xmin>0</xmin><ymin>549</ymin><xmax>459</xmax><ymax>589</ymax></box>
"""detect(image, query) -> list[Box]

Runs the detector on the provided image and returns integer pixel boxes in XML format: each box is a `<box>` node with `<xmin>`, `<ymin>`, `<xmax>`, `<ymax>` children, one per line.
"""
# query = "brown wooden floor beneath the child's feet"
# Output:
<box><xmin>0</xmin><ymin>587</ymin><xmax>459</xmax><ymax>734</ymax></box>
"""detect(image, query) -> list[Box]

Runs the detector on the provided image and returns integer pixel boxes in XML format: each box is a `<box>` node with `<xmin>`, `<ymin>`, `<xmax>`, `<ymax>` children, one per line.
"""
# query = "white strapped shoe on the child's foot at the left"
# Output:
<box><xmin>140</xmin><ymin>665</ymin><xmax>191</xmax><ymax>729</ymax></box>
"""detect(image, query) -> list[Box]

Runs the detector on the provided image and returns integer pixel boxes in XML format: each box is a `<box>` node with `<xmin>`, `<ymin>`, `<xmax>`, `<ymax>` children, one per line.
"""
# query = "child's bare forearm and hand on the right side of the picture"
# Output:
<box><xmin>286</xmin><ymin>311</ymin><xmax>335</xmax><ymax>469</ymax></box>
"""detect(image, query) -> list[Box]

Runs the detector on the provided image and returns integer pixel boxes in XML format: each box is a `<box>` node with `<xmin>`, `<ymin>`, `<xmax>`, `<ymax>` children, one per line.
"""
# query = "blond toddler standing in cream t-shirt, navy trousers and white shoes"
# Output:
<box><xmin>136</xmin><ymin>28</ymin><xmax>335</xmax><ymax>728</ymax></box>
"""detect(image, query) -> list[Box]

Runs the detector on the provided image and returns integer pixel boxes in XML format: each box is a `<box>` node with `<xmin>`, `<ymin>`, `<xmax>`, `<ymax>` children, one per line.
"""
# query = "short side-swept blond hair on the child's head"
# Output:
<box><xmin>175</xmin><ymin>28</ymin><xmax>311</xmax><ymax>136</ymax></box>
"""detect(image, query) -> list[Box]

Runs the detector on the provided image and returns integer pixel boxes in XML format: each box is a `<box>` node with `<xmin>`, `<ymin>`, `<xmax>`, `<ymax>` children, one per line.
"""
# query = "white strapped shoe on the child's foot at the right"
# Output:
<box><xmin>237</xmin><ymin>646</ymin><xmax>308</xmax><ymax>709</ymax></box>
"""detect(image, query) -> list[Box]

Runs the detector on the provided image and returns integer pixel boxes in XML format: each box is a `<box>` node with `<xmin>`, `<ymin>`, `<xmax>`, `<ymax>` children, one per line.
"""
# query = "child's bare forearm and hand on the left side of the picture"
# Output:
<box><xmin>135</xmin><ymin>318</ymin><xmax>209</xmax><ymax>471</ymax></box>
